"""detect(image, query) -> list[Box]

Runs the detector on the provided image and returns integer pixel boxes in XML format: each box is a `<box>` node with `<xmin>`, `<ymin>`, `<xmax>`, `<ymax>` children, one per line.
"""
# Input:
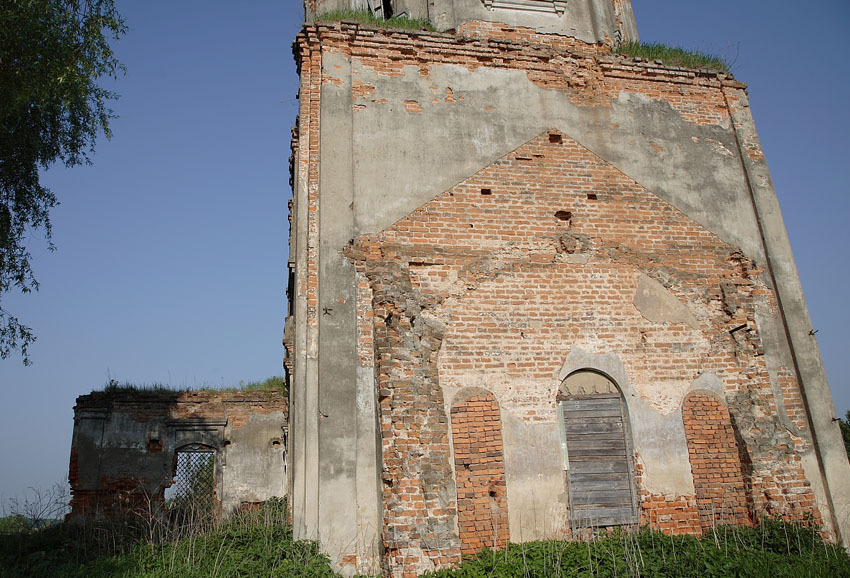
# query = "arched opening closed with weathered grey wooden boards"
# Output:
<box><xmin>558</xmin><ymin>371</ymin><xmax>638</xmax><ymax>529</ymax></box>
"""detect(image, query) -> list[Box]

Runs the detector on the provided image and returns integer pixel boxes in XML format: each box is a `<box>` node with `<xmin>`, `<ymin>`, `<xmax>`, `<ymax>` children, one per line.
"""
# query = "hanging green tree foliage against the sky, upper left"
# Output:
<box><xmin>0</xmin><ymin>0</ymin><xmax>126</xmax><ymax>364</ymax></box>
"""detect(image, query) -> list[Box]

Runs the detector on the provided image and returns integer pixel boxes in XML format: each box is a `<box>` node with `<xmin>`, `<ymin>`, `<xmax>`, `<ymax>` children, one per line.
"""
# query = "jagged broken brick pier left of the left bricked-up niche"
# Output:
<box><xmin>367</xmin><ymin>261</ymin><xmax>460</xmax><ymax>575</ymax></box>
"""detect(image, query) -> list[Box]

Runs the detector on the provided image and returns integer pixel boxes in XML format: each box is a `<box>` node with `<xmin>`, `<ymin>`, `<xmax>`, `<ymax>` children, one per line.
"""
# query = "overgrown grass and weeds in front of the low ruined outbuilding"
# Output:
<box><xmin>0</xmin><ymin>500</ymin><xmax>334</xmax><ymax>578</ymax></box>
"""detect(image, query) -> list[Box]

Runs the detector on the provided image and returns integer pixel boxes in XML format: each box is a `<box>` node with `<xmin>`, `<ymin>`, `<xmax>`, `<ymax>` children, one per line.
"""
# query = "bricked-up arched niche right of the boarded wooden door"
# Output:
<box><xmin>682</xmin><ymin>391</ymin><xmax>752</xmax><ymax>530</ymax></box>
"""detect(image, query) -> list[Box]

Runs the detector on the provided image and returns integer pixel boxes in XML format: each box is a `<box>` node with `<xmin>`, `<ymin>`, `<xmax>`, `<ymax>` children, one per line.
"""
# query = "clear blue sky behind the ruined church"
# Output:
<box><xmin>0</xmin><ymin>0</ymin><xmax>850</xmax><ymax>499</ymax></box>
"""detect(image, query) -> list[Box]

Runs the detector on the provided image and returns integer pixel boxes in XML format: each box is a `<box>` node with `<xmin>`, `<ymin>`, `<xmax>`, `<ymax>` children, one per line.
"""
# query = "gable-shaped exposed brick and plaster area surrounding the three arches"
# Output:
<box><xmin>348</xmin><ymin>131</ymin><xmax>819</xmax><ymax>571</ymax></box>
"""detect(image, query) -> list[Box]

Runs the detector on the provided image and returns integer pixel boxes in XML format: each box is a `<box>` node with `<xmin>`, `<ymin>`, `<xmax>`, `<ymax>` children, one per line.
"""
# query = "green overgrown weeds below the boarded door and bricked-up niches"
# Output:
<box><xmin>426</xmin><ymin>520</ymin><xmax>850</xmax><ymax>578</ymax></box>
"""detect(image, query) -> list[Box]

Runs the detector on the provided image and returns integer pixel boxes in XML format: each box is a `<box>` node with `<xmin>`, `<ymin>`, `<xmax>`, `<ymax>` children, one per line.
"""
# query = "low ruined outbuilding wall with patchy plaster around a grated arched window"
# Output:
<box><xmin>69</xmin><ymin>391</ymin><xmax>288</xmax><ymax>516</ymax></box>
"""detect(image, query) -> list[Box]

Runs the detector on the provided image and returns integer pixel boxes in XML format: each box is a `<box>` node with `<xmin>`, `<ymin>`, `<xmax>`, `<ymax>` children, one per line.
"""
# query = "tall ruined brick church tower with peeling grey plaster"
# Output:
<box><xmin>285</xmin><ymin>0</ymin><xmax>850</xmax><ymax>576</ymax></box>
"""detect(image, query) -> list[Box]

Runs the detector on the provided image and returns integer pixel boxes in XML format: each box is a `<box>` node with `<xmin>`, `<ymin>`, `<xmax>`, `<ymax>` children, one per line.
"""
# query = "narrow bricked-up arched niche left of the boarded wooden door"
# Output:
<box><xmin>451</xmin><ymin>389</ymin><xmax>510</xmax><ymax>554</ymax></box>
